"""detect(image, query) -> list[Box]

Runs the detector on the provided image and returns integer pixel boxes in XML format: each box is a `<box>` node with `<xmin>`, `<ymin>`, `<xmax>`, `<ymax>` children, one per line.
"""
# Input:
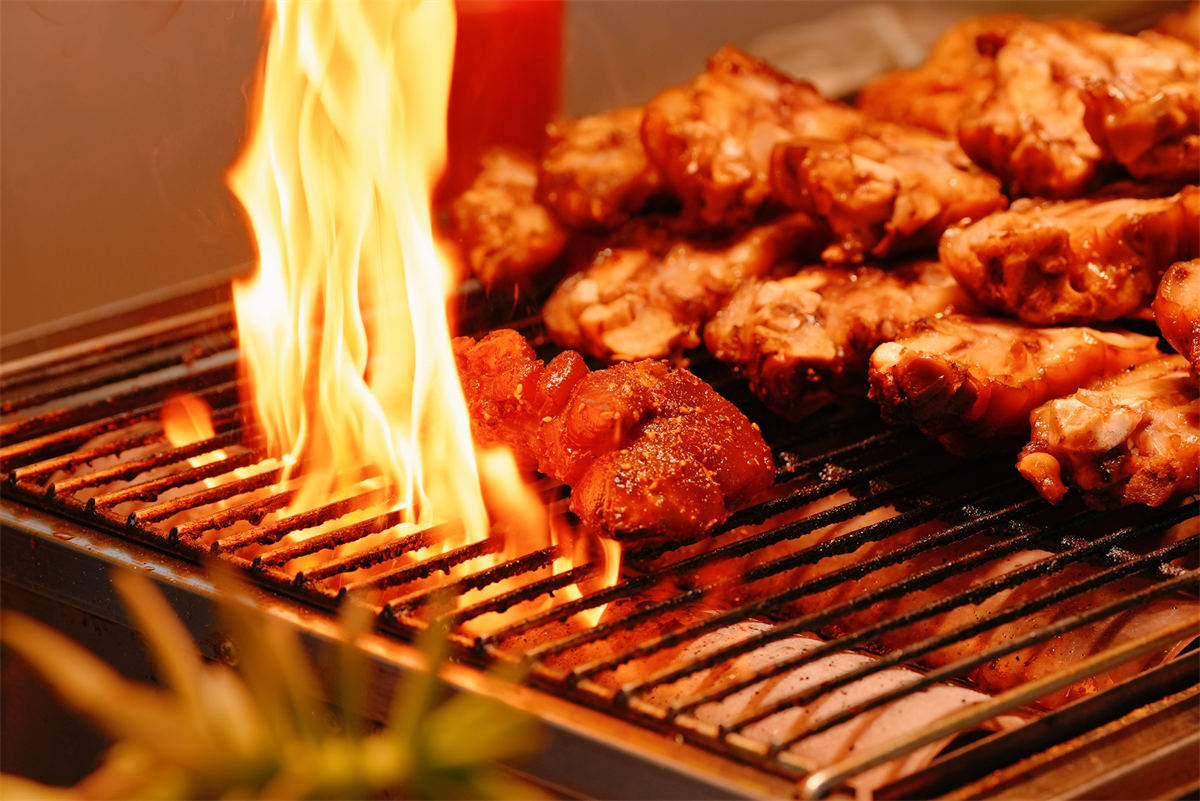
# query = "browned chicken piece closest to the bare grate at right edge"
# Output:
<box><xmin>1016</xmin><ymin>356</ymin><xmax>1200</xmax><ymax>508</ymax></box>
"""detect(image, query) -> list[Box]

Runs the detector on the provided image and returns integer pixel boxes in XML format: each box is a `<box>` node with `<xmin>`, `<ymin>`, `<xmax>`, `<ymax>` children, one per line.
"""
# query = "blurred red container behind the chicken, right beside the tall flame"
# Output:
<box><xmin>438</xmin><ymin>0</ymin><xmax>563</xmax><ymax>200</ymax></box>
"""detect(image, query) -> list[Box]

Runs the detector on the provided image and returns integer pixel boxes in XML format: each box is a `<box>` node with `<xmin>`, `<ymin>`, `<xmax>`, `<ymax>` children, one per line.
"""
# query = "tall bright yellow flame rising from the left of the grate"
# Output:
<box><xmin>229</xmin><ymin>0</ymin><xmax>488</xmax><ymax>541</ymax></box>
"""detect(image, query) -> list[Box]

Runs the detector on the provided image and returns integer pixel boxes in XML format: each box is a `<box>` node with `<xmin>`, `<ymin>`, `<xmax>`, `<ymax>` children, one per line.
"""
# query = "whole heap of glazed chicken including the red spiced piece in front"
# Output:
<box><xmin>449</xmin><ymin>6</ymin><xmax>1200</xmax><ymax>537</ymax></box>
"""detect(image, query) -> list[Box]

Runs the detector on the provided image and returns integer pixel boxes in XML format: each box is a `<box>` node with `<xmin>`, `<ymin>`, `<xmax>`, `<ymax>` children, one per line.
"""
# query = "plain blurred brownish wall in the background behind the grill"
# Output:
<box><xmin>0</xmin><ymin>0</ymin><xmax>1172</xmax><ymax>335</ymax></box>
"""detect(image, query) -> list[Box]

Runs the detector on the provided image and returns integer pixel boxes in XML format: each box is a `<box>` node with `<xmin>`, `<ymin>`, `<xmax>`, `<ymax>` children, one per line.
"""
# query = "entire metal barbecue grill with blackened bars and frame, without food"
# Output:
<box><xmin>0</xmin><ymin>276</ymin><xmax>1200</xmax><ymax>797</ymax></box>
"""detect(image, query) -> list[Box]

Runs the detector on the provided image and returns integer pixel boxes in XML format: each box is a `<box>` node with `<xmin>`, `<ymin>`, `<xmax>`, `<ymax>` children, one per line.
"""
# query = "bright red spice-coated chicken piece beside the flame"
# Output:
<box><xmin>454</xmin><ymin>331</ymin><xmax>775</xmax><ymax>538</ymax></box>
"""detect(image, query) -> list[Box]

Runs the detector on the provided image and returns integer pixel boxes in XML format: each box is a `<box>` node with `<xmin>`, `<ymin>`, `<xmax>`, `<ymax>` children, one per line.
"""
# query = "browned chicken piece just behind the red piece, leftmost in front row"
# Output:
<box><xmin>704</xmin><ymin>261</ymin><xmax>976</xmax><ymax>420</ymax></box>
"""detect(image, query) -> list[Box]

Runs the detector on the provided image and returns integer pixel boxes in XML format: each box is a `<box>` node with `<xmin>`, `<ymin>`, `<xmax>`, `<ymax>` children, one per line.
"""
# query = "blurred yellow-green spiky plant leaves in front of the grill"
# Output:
<box><xmin>0</xmin><ymin>572</ymin><xmax>541</xmax><ymax>799</ymax></box>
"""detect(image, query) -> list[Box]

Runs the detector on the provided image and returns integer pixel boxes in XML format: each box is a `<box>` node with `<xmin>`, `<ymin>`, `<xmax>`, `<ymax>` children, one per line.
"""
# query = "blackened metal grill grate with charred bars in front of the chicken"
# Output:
<box><xmin>0</xmin><ymin>305</ymin><xmax>1200</xmax><ymax>796</ymax></box>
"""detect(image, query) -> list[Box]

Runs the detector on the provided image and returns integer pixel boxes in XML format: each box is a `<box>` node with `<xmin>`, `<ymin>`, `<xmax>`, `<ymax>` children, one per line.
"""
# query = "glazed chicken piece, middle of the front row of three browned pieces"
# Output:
<box><xmin>869</xmin><ymin>315</ymin><xmax>1159</xmax><ymax>456</ymax></box>
